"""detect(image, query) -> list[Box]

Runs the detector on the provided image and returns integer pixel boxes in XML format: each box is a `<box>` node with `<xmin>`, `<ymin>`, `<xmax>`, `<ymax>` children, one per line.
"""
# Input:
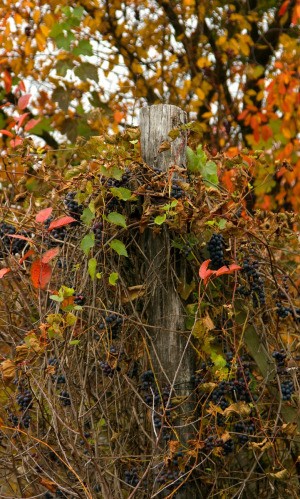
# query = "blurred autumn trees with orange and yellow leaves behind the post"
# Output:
<box><xmin>0</xmin><ymin>0</ymin><xmax>300</xmax><ymax>208</ymax></box>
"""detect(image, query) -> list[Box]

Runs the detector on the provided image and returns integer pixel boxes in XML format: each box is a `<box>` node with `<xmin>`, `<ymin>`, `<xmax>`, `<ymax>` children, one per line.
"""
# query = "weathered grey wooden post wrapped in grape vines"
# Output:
<box><xmin>140</xmin><ymin>105</ymin><xmax>201</xmax><ymax>499</ymax></box>
